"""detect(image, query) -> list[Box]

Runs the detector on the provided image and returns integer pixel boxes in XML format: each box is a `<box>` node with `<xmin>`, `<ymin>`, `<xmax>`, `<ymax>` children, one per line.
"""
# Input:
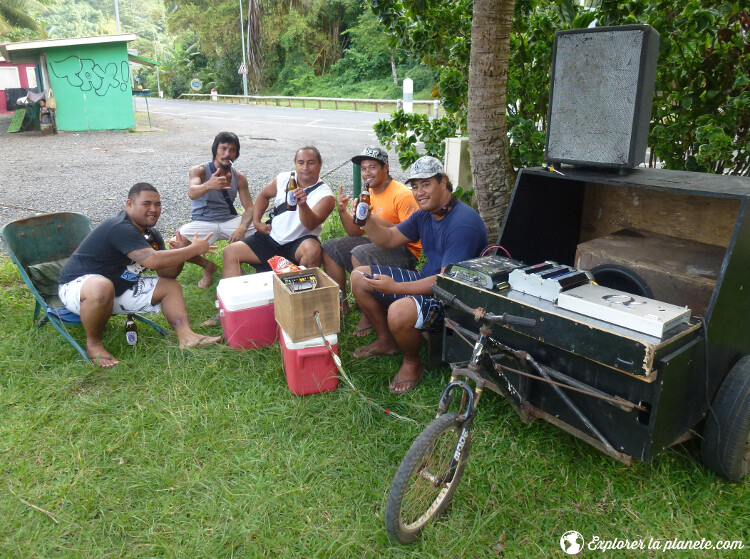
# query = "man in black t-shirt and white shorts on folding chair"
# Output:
<box><xmin>58</xmin><ymin>182</ymin><xmax>221</xmax><ymax>368</ymax></box>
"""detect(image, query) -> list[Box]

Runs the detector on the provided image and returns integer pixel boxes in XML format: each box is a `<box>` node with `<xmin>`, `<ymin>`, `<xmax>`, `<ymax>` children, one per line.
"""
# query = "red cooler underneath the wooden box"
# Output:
<box><xmin>279</xmin><ymin>326</ymin><xmax>339</xmax><ymax>396</ymax></box>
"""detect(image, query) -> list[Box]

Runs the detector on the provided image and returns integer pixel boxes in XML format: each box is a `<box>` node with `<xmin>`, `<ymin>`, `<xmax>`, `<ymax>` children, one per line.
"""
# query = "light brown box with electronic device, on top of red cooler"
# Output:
<box><xmin>273</xmin><ymin>268</ymin><xmax>341</xmax><ymax>342</ymax></box>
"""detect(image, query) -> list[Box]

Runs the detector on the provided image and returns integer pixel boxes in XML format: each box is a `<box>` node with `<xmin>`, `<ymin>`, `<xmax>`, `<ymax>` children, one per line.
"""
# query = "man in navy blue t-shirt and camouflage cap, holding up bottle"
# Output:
<box><xmin>351</xmin><ymin>156</ymin><xmax>487</xmax><ymax>394</ymax></box>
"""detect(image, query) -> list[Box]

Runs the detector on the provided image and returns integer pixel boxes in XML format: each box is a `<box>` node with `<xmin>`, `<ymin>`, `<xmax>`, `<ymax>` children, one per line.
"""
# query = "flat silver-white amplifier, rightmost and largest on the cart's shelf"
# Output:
<box><xmin>557</xmin><ymin>284</ymin><xmax>690</xmax><ymax>338</ymax></box>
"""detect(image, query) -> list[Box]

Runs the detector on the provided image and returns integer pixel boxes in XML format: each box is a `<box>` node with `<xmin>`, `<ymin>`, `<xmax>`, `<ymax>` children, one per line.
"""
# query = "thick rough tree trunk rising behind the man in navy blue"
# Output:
<box><xmin>467</xmin><ymin>0</ymin><xmax>515</xmax><ymax>242</ymax></box>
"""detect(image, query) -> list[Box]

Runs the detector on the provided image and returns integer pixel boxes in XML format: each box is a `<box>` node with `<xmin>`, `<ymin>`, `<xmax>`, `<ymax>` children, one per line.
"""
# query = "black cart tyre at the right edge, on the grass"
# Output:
<box><xmin>701</xmin><ymin>355</ymin><xmax>750</xmax><ymax>482</ymax></box>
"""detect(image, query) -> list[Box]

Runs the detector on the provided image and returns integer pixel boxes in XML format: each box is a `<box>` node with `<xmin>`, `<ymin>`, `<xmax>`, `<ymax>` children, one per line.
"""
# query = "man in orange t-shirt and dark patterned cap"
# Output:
<box><xmin>323</xmin><ymin>147</ymin><xmax>422</xmax><ymax>337</ymax></box>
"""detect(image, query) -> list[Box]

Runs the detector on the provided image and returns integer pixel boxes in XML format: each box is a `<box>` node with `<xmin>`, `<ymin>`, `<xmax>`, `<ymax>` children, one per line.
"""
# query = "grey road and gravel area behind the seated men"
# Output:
<box><xmin>0</xmin><ymin>98</ymin><xmax>403</xmax><ymax>231</ymax></box>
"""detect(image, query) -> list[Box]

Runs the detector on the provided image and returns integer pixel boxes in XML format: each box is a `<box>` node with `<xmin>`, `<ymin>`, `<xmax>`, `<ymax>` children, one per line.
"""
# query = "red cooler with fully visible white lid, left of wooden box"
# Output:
<box><xmin>216</xmin><ymin>272</ymin><xmax>277</xmax><ymax>348</ymax></box>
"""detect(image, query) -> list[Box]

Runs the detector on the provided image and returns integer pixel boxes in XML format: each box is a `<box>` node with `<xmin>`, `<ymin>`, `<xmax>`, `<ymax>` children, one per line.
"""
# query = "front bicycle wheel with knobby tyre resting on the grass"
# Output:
<box><xmin>385</xmin><ymin>413</ymin><xmax>471</xmax><ymax>543</ymax></box>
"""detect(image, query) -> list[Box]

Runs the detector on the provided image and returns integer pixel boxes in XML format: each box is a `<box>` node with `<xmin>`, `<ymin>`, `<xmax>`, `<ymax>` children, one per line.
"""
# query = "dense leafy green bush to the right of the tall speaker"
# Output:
<box><xmin>598</xmin><ymin>0</ymin><xmax>750</xmax><ymax>175</ymax></box>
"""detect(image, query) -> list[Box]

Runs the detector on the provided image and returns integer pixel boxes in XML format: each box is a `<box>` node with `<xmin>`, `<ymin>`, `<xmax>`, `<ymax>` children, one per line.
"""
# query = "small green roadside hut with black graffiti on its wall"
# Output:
<box><xmin>0</xmin><ymin>34</ymin><xmax>150</xmax><ymax>131</ymax></box>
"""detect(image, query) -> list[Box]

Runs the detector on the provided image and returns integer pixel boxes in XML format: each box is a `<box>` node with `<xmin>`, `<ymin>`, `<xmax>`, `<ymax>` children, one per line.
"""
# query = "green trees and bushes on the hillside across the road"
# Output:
<box><xmin>29</xmin><ymin>0</ymin><xmax>433</xmax><ymax>98</ymax></box>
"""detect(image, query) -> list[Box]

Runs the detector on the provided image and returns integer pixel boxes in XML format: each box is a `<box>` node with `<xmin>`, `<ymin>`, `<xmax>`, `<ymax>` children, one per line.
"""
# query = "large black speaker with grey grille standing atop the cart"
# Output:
<box><xmin>545</xmin><ymin>25</ymin><xmax>659</xmax><ymax>169</ymax></box>
